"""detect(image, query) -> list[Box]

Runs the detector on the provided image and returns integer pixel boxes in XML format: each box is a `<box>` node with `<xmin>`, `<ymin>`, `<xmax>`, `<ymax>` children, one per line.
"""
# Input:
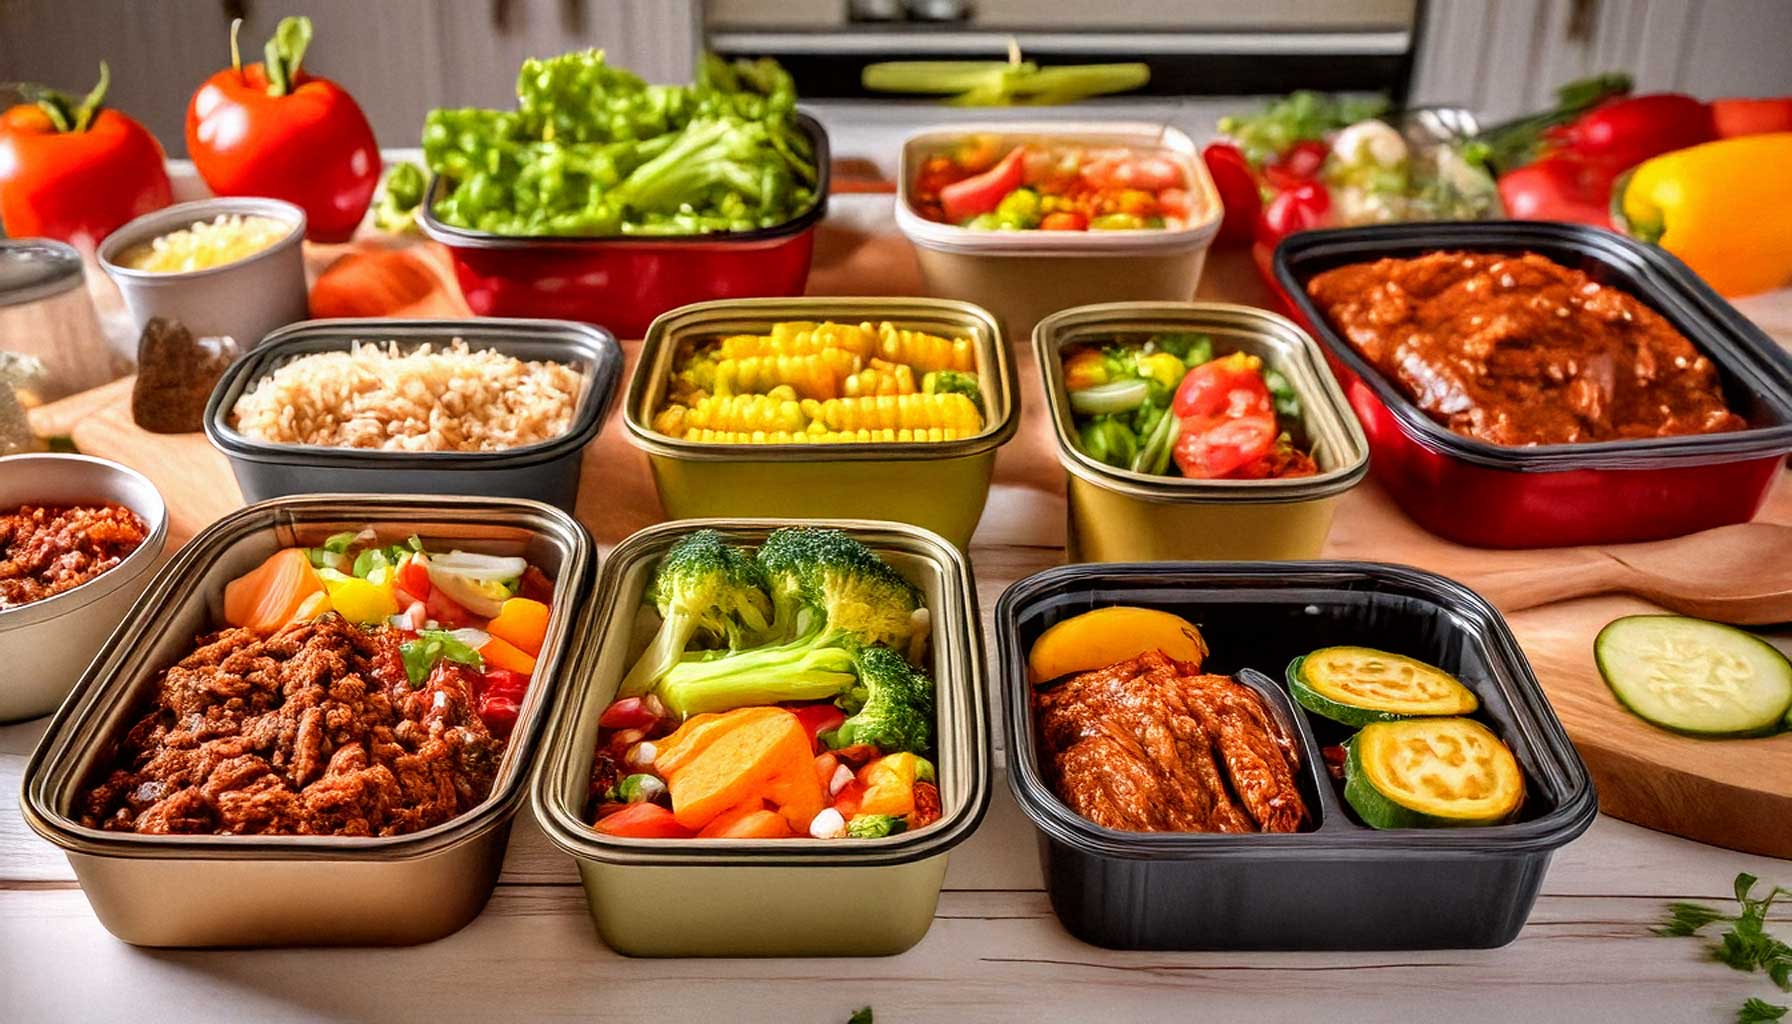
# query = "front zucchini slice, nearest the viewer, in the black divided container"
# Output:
<box><xmin>1344</xmin><ymin>717</ymin><xmax>1525</xmax><ymax>829</ymax></box>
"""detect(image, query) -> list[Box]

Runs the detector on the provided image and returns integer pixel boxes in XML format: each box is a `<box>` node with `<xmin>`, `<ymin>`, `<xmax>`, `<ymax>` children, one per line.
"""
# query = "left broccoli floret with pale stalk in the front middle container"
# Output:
<box><xmin>616</xmin><ymin>529</ymin><xmax>772</xmax><ymax>698</ymax></box>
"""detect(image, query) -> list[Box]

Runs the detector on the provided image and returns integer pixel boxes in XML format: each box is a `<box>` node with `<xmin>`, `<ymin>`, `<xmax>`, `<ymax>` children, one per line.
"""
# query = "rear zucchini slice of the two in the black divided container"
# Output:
<box><xmin>1287</xmin><ymin>647</ymin><xmax>1480</xmax><ymax>726</ymax></box>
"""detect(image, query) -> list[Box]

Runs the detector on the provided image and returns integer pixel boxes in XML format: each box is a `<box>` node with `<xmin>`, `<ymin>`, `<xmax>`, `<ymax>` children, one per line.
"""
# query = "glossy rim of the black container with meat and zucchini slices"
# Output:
<box><xmin>995</xmin><ymin>561</ymin><xmax>1598</xmax><ymax>861</ymax></box>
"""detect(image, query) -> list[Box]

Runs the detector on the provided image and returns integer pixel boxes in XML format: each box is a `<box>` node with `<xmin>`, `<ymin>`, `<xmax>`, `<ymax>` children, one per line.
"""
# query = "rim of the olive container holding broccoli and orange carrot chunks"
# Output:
<box><xmin>529</xmin><ymin>518</ymin><xmax>993</xmax><ymax>868</ymax></box>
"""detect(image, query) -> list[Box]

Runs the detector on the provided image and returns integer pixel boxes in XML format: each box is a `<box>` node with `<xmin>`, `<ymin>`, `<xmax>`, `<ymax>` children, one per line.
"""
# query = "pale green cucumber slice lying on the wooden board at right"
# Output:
<box><xmin>1593</xmin><ymin>615</ymin><xmax>1792</xmax><ymax>737</ymax></box>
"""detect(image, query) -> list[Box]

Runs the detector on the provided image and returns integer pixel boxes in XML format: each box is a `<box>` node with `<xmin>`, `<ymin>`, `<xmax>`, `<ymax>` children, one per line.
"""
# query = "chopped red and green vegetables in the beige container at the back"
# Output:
<box><xmin>914</xmin><ymin>135</ymin><xmax>1197</xmax><ymax>231</ymax></box>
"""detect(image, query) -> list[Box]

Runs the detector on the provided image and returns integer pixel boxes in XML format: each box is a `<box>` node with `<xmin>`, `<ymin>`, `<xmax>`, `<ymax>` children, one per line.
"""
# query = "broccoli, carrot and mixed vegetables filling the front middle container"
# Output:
<box><xmin>590</xmin><ymin>527</ymin><xmax>941</xmax><ymax>839</ymax></box>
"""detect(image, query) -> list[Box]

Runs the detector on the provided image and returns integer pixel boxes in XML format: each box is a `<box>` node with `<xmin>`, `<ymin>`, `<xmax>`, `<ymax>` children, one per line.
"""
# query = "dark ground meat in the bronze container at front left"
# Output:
<box><xmin>81</xmin><ymin>615</ymin><xmax>504</xmax><ymax>836</ymax></box>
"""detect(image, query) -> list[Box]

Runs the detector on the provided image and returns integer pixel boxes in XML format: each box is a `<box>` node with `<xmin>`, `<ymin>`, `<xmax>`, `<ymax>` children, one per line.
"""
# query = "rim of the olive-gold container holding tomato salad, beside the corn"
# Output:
<box><xmin>1032</xmin><ymin>301</ymin><xmax>1369</xmax><ymax>504</ymax></box>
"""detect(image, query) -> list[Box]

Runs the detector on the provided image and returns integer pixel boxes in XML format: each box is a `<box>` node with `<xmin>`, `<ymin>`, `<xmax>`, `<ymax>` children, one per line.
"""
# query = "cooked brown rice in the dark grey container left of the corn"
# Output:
<box><xmin>231</xmin><ymin>337</ymin><xmax>581</xmax><ymax>452</ymax></box>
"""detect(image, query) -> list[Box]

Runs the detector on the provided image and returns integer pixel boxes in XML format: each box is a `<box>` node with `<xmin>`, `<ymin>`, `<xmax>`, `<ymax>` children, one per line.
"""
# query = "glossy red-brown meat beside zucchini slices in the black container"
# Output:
<box><xmin>1034</xmin><ymin>651</ymin><xmax>1306</xmax><ymax>832</ymax></box>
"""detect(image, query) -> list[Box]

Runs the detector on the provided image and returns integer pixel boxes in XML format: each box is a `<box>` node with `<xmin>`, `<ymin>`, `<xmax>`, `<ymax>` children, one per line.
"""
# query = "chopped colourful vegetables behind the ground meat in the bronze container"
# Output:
<box><xmin>224</xmin><ymin>529</ymin><xmax>554</xmax><ymax>739</ymax></box>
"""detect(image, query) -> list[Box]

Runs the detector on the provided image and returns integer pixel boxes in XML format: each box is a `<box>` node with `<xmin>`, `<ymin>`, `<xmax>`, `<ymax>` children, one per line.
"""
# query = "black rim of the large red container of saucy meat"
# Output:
<box><xmin>1274</xmin><ymin>221</ymin><xmax>1792</xmax><ymax>472</ymax></box>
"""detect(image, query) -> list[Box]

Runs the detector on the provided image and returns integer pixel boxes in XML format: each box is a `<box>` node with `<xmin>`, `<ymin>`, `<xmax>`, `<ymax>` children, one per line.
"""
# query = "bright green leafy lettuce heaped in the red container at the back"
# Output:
<box><xmin>415</xmin><ymin>50</ymin><xmax>817</xmax><ymax>235</ymax></box>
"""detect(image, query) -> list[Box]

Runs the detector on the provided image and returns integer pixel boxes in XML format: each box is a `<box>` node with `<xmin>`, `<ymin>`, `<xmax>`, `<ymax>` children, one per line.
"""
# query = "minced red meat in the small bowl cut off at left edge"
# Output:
<box><xmin>0</xmin><ymin>504</ymin><xmax>149</xmax><ymax>610</ymax></box>
